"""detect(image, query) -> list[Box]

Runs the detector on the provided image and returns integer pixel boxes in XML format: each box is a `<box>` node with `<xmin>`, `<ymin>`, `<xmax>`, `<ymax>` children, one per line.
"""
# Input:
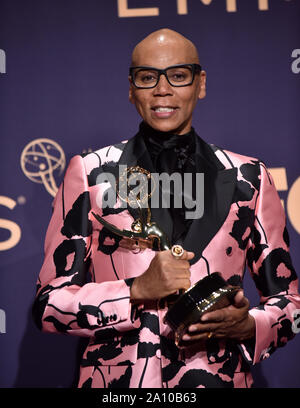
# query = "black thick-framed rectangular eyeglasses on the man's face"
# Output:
<box><xmin>129</xmin><ymin>64</ymin><xmax>202</xmax><ymax>89</ymax></box>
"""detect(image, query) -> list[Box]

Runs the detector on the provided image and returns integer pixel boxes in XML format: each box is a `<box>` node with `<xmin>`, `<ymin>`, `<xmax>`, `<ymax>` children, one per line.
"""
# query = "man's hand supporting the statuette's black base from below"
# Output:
<box><xmin>181</xmin><ymin>290</ymin><xmax>255</xmax><ymax>346</ymax></box>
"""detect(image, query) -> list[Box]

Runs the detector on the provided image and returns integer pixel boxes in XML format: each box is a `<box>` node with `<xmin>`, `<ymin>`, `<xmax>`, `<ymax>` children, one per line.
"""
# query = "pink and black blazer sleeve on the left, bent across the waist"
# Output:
<box><xmin>32</xmin><ymin>156</ymin><xmax>140</xmax><ymax>337</ymax></box>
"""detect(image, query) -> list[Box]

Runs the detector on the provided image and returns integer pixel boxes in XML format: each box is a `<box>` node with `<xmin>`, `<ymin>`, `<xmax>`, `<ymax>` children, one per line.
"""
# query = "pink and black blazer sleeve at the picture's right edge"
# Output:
<box><xmin>240</xmin><ymin>163</ymin><xmax>300</xmax><ymax>364</ymax></box>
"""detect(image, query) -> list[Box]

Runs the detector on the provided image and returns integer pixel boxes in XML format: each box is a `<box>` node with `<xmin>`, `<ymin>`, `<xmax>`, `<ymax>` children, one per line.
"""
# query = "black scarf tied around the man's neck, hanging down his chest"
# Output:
<box><xmin>140</xmin><ymin>122</ymin><xmax>196</xmax><ymax>244</ymax></box>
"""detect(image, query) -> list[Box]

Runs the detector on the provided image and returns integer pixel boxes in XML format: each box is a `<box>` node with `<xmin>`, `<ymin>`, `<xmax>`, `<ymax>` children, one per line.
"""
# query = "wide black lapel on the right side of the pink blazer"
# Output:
<box><xmin>183</xmin><ymin>136</ymin><xmax>237</xmax><ymax>264</ymax></box>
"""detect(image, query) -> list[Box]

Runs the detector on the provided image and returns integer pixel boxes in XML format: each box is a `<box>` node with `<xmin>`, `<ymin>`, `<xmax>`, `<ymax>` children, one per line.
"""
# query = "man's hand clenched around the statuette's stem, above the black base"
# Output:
<box><xmin>130</xmin><ymin>250</ymin><xmax>195</xmax><ymax>301</ymax></box>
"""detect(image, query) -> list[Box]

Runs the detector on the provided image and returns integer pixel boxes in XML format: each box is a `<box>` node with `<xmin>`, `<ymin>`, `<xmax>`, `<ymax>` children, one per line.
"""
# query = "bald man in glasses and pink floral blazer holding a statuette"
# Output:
<box><xmin>33</xmin><ymin>29</ymin><xmax>300</xmax><ymax>388</ymax></box>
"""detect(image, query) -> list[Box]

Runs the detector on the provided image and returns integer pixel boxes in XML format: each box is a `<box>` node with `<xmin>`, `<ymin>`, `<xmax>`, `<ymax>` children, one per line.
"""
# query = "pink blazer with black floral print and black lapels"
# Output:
<box><xmin>33</xmin><ymin>134</ymin><xmax>300</xmax><ymax>388</ymax></box>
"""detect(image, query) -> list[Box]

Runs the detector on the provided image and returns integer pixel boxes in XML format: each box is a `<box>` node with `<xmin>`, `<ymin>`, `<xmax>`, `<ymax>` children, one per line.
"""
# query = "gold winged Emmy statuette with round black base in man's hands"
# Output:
<box><xmin>92</xmin><ymin>166</ymin><xmax>240</xmax><ymax>345</ymax></box>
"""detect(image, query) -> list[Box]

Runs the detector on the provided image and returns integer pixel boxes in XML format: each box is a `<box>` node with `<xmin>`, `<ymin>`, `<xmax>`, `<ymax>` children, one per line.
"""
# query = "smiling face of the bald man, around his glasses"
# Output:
<box><xmin>129</xmin><ymin>37</ymin><xmax>206</xmax><ymax>134</ymax></box>
